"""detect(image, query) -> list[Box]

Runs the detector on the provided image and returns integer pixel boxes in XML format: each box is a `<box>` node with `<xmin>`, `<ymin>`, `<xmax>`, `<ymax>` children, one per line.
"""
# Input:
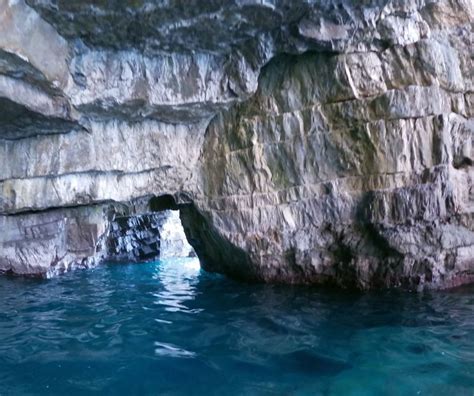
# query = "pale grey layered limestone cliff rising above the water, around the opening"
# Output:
<box><xmin>0</xmin><ymin>0</ymin><xmax>474</xmax><ymax>289</ymax></box>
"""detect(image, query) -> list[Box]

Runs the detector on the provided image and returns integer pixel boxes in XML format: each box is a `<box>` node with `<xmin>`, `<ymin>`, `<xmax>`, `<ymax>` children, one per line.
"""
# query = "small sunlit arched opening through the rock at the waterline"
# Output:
<box><xmin>103</xmin><ymin>195</ymin><xmax>200</xmax><ymax>268</ymax></box>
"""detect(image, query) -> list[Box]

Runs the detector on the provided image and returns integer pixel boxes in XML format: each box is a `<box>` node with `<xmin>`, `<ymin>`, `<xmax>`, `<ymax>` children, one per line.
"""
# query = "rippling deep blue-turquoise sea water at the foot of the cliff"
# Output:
<box><xmin>0</xmin><ymin>259</ymin><xmax>474</xmax><ymax>396</ymax></box>
